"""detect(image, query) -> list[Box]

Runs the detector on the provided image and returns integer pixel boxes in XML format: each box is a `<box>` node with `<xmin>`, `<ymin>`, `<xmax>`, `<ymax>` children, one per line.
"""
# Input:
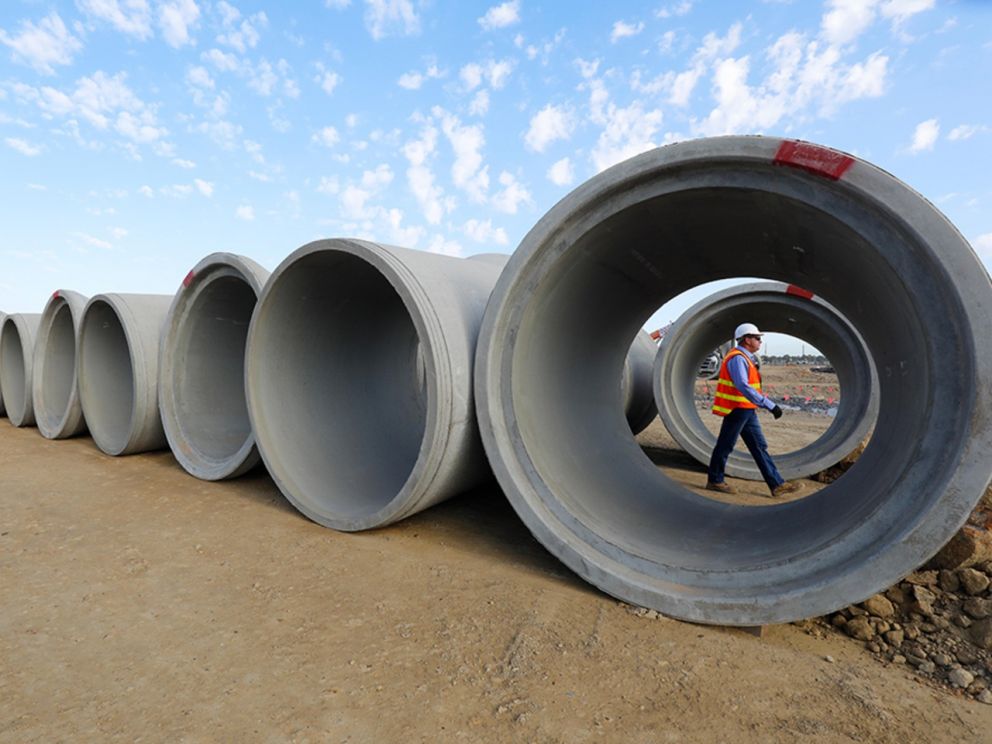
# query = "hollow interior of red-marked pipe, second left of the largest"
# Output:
<box><xmin>169</xmin><ymin>276</ymin><xmax>257</xmax><ymax>462</ymax></box>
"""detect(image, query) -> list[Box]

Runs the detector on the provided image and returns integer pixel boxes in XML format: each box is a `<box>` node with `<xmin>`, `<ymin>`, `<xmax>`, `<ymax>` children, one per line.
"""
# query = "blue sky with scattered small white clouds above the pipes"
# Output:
<box><xmin>0</xmin><ymin>0</ymin><xmax>992</xmax><ymax>351</ymax></box>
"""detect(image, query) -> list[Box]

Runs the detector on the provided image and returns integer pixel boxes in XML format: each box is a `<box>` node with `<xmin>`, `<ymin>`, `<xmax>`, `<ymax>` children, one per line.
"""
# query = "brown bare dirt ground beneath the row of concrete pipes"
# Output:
<box><xmin>0</xmin><ymin>370</ymin><xmax>992</xmax><ymax>744</ymax></box>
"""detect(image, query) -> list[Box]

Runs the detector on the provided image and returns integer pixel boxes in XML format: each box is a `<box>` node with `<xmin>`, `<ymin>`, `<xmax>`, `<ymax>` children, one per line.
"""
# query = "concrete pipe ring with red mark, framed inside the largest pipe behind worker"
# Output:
<box><xmin>654</xmin><ymin>282</ymin><xmax>878</xmax><ymax>480</ymax></box>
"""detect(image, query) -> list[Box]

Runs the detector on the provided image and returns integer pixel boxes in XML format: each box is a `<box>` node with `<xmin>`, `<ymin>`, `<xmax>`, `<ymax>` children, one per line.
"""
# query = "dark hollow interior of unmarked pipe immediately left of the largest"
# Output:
<box><xmin>248</xmin><ymin>250</ymin><xmax>426</xmax><ymax>527</ymax></box>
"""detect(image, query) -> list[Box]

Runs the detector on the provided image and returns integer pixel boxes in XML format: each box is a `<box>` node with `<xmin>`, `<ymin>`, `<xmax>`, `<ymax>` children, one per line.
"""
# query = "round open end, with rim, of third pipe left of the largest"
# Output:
<box><xmin>76</xmin><ymin>294</ymin><xmax>145</xmax><ymax>456</ymax></box>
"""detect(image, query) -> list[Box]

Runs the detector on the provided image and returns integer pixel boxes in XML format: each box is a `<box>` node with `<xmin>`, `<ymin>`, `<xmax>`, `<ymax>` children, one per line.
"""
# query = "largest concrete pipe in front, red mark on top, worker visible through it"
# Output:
<box><xmin>476</xmin><ymin>137</ymin><xmax>992</xmax><ymax>625</ymax></box>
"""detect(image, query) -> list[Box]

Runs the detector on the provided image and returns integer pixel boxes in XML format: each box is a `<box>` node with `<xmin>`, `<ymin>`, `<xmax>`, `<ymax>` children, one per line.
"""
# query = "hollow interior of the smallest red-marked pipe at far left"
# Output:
<box><xmin>34</xmin><ymin>302</ymin><xmax>76</xmax><ymax>429</ymax></box>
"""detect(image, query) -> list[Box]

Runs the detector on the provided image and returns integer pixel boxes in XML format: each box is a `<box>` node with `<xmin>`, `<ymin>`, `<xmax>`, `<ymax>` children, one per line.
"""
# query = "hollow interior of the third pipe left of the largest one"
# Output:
<box><xmin>78</xmin><ymin>300</ymin><xmax>135</xmax><ymax>452</ymax></box>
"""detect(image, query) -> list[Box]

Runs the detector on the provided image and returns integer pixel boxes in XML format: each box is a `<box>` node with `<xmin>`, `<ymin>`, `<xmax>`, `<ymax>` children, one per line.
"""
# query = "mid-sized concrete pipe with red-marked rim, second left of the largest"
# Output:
<box><xmin>159</xmin><ymin>253</ymin><xmax>269</xmax><ymax>480</ymax></box>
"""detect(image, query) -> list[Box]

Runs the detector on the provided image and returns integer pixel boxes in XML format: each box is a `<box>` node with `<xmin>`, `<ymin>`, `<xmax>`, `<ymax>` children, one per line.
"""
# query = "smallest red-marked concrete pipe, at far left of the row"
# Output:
<box><xmin>32</xmin><ymin>289</ymin><xmax>88</xmax><ymax>439</ymax></box>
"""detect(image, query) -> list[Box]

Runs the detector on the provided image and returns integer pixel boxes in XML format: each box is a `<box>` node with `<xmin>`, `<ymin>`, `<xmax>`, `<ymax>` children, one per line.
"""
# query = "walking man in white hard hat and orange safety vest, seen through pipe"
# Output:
<box><xmin>706</xmin><ymin>323</ymin><xmax>802</xmax><ymax>497</ymax></box>
